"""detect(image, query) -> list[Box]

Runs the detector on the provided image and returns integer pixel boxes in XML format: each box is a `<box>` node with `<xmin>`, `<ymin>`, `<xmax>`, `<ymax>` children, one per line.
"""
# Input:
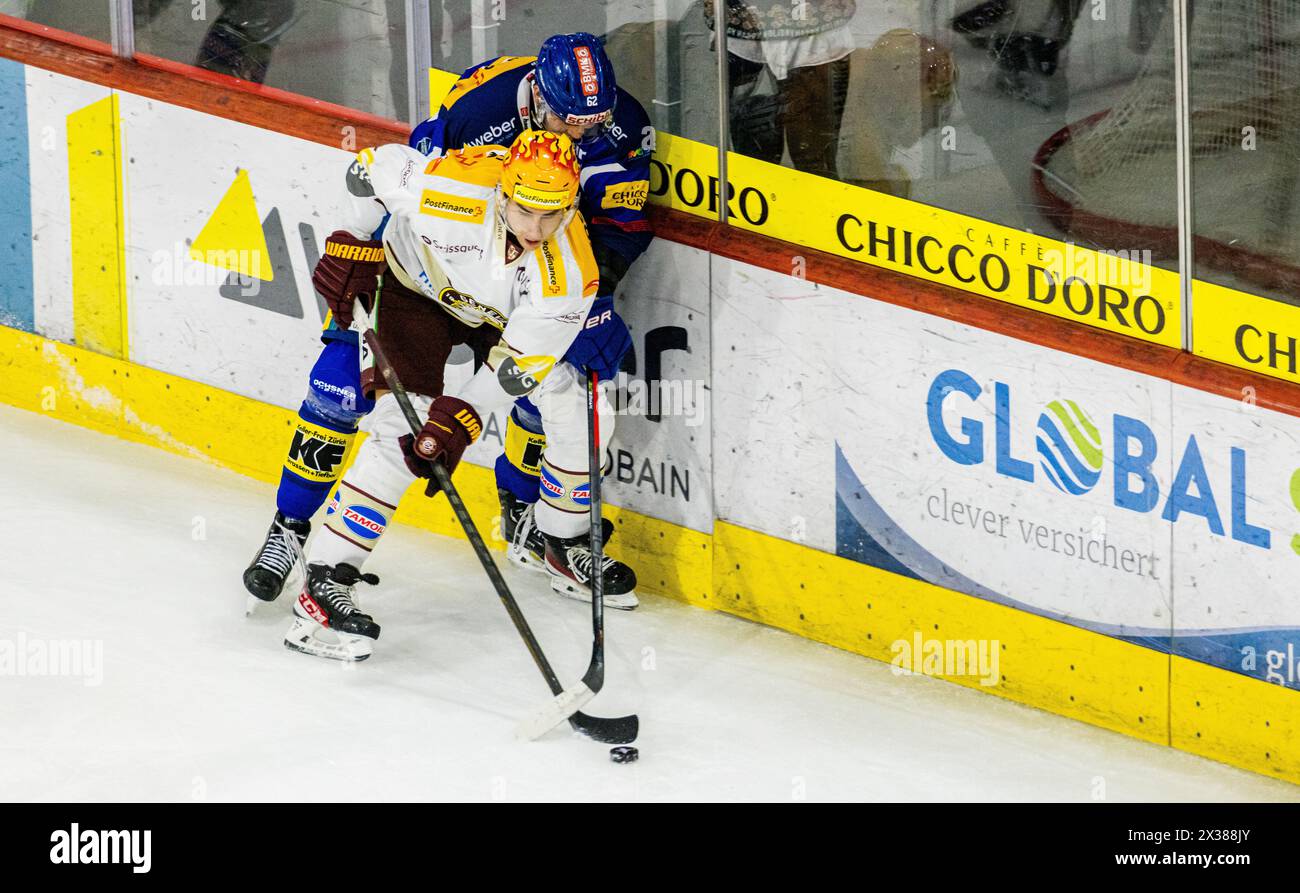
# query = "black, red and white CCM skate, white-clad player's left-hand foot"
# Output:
<box><xmin>285</xmin><ymin>564</ymin><xmax>380</xmax><ymax>660</ymax></box>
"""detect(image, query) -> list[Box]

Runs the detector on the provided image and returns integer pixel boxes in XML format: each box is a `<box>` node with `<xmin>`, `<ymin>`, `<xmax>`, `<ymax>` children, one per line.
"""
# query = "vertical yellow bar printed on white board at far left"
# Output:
<box><xmin>68</xmin><ymin>92</ymin><xmax>130</xmax><ymax>359</ymax></box>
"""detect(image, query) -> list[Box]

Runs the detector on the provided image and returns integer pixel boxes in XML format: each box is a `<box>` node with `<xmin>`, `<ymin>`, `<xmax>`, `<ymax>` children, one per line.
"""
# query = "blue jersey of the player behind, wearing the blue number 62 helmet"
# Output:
<box><xmin>411</xmin><ymin>56</ymin><xmax>655</xmax><ymax>279</ymax></box>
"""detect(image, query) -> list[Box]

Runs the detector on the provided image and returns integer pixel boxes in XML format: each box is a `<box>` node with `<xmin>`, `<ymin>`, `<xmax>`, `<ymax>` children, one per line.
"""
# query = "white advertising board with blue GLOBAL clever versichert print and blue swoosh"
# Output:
<box><xmin>714</xmin><ymin>254</ymin><xmax>1300</xmax><ymax>686</ymax></box>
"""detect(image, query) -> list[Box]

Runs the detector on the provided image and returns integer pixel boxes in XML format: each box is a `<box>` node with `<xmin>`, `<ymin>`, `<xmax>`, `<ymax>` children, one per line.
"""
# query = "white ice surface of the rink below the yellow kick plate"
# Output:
<box><xmin>0</xmin><ymin>407</ymin><xmax>1300</xmax><ymax>802</ymax></box>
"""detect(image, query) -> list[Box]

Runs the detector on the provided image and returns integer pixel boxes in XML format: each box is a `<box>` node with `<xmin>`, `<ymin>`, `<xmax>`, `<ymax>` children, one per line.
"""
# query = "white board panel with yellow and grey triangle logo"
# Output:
<box><xmin>121</xmin><ymin>94</ymin><xmax>348</xmax><ymax>407</ymax></box>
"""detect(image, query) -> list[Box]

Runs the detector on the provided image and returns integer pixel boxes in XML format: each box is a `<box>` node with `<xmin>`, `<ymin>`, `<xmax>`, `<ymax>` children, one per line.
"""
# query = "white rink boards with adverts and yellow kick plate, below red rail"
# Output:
<box><xmin>0</xmin><ymin>54</ymin><xmax>1300</xmax><ymax>781</ymax></box>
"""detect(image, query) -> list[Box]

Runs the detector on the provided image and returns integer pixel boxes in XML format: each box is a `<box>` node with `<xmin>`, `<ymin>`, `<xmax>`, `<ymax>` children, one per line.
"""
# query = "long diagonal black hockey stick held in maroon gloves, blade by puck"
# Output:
<box><xmin>354</xmin><ymin>289</ymin><xmax>638</xmax><ymax>744</ymax></box>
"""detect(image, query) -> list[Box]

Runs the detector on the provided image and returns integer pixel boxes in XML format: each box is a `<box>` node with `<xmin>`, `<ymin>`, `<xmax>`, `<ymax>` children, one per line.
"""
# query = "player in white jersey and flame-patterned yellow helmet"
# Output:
<box><xmin>293</xmin><ymin>130</ymin><xmax>636</xmax><ymax>660</ymax></box>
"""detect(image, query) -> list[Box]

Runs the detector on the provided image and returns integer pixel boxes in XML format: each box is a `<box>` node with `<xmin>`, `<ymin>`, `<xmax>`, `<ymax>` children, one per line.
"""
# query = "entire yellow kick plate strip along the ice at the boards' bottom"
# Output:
<box><xmin>0</xmin><ymin>328</ymin><xmax>1300</xmax><ymax>784</ymax></box>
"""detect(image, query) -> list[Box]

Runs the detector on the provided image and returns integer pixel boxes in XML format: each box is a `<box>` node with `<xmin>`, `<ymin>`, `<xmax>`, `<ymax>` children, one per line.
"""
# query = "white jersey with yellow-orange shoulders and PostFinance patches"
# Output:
<box><xmin>347</xmin><ymin>144</ymin><xmax>599</xmax><ymax>417</ymax></box>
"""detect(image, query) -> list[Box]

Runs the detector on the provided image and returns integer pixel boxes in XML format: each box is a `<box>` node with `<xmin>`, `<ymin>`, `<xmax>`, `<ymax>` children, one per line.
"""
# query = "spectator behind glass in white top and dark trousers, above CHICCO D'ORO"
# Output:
<box><xmin>702</xmin><ymin>0</ymin><xmax>857</xmax><ymax>179</ymax></box>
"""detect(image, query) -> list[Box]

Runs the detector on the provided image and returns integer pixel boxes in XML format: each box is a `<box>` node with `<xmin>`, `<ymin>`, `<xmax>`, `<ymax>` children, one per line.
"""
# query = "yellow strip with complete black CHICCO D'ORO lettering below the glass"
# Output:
<box><xmin>650</xmin><ymin>134</ymin><xmax>1183</xmax><ymax>347</ymax></box>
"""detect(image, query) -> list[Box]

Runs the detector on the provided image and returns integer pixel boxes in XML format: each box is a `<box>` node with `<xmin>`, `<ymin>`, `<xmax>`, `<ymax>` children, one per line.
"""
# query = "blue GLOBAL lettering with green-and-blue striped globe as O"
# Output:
<box><xmin>926</xmin><ymin>369</ymin><xmax>1268</xmax><ymax>549</ymax></box>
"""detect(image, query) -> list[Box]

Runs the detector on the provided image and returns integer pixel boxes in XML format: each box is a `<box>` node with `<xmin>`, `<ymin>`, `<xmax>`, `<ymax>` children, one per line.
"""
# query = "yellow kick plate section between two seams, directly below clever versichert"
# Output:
<box><xmin>714</xmin><ymin>521</ymin><xmax>1170</xmax><ymax>744</ymax></box>
